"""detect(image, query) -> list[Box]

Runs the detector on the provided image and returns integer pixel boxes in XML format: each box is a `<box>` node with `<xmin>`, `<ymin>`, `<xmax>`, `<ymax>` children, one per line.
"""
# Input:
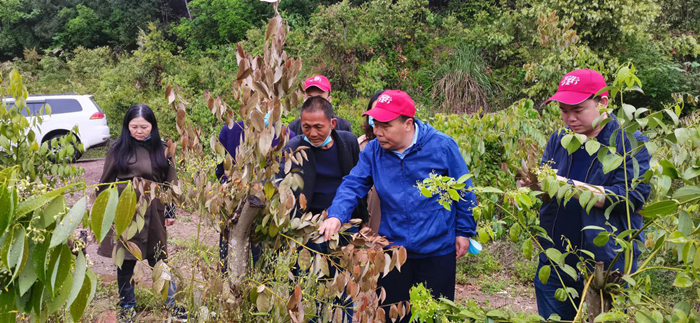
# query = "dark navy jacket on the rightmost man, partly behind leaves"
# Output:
<box><xmin>540</xmin><ymin>115</ymin><xmax>651</xmax><ymax>271</ymax></box>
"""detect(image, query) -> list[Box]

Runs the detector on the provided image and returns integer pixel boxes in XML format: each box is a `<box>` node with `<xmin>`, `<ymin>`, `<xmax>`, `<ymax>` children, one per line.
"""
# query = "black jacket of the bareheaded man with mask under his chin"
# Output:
<box><xmin>278</xmin><ymin>130</ymin><xmax>369</xmax><ymax>223</ymax></box>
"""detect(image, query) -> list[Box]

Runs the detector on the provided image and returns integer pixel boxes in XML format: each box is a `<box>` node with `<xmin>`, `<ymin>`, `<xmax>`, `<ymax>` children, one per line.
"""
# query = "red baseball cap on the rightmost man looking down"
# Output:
<box><xmin>545</xmin><ymin>69</ymin><xmax>609</xmax><ymax>105</ymax></box>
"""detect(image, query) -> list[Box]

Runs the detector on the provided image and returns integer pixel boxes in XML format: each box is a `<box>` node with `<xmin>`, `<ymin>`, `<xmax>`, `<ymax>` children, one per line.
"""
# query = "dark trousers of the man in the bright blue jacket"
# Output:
<box><xmin>378</xmin><ymin>251</ymin><xmax>457</xmax><ymax>323</ymax></box>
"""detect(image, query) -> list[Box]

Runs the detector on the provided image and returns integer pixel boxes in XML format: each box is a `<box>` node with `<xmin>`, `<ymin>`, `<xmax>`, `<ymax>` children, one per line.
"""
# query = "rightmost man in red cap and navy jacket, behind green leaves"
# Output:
<box><xmin>518</xmin><ymin>69</ymin><xmax>650</xmax><ymax>321</ymax></box>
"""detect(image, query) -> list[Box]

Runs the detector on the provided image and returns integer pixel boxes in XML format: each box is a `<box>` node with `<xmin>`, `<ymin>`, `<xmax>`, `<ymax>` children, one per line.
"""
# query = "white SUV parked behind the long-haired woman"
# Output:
<box><xmin>6</xmin><ymin>94</ymin><xmax>109</xmax><ymax>160</ymax></box>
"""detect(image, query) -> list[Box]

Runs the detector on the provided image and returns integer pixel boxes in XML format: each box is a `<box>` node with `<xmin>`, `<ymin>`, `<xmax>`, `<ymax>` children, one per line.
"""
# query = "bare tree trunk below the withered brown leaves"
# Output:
<box><xmin>227</xmin><ymin>196</ymin><xmax>265</xmax><ymax>290</ymax></box>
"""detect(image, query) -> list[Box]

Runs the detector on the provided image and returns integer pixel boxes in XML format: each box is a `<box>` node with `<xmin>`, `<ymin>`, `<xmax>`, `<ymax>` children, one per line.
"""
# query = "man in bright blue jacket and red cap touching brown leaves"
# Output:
<box><xmin>319</xmin><ymin>90</ymin><xmax>476</xmax><ymax>322</ymax></box>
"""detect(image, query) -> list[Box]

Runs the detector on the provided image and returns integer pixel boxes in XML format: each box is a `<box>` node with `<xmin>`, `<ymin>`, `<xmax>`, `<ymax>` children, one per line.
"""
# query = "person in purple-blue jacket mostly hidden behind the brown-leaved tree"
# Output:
<box><xmin>215</xmin><ymin>112</ymin><xmax>296</xmax><ymax>275</ymax></box>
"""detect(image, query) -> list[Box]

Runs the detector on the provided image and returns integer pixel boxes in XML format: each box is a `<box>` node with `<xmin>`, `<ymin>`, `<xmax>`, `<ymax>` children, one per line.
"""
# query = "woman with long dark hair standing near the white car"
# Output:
<box><xmin>97</xmin><ymin>104</ymin><xmax>187</xmax><ymax>322</ymax></box>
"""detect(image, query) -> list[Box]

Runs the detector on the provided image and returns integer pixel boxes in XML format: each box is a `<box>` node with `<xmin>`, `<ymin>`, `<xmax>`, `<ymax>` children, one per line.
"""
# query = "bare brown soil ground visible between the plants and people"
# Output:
<box><xmin>76</xmin><ymin>158</ymin><xmax>537</xmax><ymax>323</ymax></box>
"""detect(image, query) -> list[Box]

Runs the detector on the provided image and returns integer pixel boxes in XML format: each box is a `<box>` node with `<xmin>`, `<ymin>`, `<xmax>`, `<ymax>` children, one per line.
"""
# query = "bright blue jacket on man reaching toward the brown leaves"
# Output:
<box><xmin>328</xmin><ymin>120</ymin><xmax>476</xmax><ymax>258</ymax></box>
